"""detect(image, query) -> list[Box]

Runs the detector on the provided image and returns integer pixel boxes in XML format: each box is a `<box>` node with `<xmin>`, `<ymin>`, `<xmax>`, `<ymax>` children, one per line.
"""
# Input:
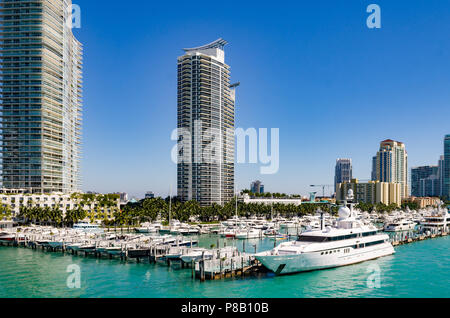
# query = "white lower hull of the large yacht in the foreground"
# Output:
<box><xmin>255</xmin><ymin>243</ymin><xmax>395</xmax><ymax>275</ymax></box>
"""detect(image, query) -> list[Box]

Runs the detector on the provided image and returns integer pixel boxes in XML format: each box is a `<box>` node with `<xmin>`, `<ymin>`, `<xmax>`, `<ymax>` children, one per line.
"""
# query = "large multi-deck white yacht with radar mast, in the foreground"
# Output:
<box><xmin>255</xmin><ymin>190</ymin><xmax>395</xmax><ymax>275</ymax></box>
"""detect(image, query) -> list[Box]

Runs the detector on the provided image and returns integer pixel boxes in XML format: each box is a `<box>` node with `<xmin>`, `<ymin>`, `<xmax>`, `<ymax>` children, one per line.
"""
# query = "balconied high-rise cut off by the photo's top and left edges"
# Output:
<box><xmin>0</xmin><ymin>0</ymin><xmax>82</xmax><ymax>193</ymax></box>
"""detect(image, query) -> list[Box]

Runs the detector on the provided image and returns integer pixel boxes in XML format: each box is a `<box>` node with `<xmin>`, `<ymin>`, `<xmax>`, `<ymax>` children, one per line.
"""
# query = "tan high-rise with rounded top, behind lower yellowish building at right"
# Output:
<box><xmin>376</xmin><ymin>139</ymin><xmax>408</xmax><ymax>198</ymax></box>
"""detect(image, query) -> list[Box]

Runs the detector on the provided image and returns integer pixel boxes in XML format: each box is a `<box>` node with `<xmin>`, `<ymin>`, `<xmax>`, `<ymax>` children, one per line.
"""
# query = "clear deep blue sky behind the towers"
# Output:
<box><xmin>74</xmin><ymin>0</ymin><xmax>450</xmax><ymax>196</ymax></box>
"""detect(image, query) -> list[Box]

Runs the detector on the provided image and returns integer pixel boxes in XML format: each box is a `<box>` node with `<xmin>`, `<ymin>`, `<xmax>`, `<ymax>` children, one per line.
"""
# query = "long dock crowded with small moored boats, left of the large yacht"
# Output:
<box><xmin>0</xmin><ymin>228</ymin><xmax>261</xmax><ymax>281</ymax></box>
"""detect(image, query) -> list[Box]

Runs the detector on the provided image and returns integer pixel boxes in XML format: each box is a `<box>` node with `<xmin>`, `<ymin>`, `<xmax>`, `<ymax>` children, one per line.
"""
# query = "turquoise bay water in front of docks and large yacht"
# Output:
<box><xmin>0</xmin><ymin>236</ymin><xmax>450</xmax><ymax>298</ymax></box>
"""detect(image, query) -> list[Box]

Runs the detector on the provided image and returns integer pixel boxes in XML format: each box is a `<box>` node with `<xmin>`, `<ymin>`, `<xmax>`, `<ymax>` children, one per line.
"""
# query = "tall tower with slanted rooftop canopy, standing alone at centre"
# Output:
<box><xmin>177</xmin><ymin>39</ymin><xmax>238</xmax><ymax>206</ymax></box>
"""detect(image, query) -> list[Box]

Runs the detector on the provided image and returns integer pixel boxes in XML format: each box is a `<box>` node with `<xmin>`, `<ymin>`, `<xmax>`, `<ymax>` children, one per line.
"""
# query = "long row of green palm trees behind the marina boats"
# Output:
<box><xmin>7</xmin><ymin>198</ymin><xmax>337</xmax><ymax>226</ymax></box>
